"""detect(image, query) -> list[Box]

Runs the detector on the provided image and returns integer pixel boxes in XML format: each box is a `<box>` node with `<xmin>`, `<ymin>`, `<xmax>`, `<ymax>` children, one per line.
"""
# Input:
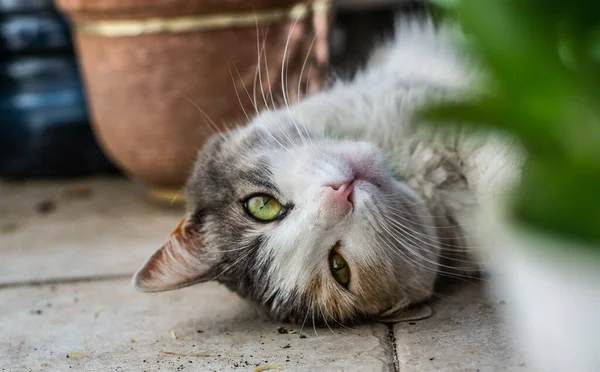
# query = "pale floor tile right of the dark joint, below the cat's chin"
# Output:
<box><xmin>394</xmin><ymin>283</ymin><xmax>526</xmax><ymax>372</ymax></box>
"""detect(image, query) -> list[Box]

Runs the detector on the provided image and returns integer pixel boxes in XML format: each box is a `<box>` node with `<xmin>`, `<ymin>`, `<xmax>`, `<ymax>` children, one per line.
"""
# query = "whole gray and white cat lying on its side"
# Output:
<box><xmin>134</xmin><ymin>21</ymin><xmax>517</xmax><ymax>323</ymax></box>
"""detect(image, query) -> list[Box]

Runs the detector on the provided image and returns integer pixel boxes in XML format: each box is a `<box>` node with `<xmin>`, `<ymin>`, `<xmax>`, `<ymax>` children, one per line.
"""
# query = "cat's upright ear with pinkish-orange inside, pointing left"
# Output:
<box><xmin>133</xmin><ymin>216</ymin><xmax>214</xmax><ymax>292</ymax></box>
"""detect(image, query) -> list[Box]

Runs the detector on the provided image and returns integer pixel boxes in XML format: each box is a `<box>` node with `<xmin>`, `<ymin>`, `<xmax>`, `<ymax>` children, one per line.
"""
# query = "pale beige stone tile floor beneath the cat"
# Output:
<box><xmin>0</xmin><ymin>179</ymin><xmax>525</xmax><ymax>372</ymax></box>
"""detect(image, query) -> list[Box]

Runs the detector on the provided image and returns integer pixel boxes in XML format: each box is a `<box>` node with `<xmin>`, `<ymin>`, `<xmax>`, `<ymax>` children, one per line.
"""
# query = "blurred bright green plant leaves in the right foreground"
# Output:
<box><xmin>424</xmin><ymin>0</ymin><xmax>600</xmax><ymax>247</ymax></box>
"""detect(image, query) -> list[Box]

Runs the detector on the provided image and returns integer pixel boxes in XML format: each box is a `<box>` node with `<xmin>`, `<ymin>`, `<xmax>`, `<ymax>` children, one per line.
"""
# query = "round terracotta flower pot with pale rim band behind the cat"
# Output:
<box><xmin>56</xmin><ymin>0</ymin><xmax>329</xmax><ymax>203</ymax></box>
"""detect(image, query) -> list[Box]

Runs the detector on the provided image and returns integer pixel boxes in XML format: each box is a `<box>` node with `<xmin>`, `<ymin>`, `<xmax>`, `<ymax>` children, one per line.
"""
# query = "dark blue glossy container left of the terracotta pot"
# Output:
<box><xmin>0</xmin><ymin>0</ymin><xmax>115</xmax><ymax>178</ymax></box>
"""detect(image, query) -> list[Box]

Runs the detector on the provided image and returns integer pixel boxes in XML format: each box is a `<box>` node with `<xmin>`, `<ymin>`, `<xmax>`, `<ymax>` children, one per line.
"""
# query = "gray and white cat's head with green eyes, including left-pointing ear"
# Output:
<box><xmin>134</xmin><ymin>114</ymin><xmax>446</xmax><ymax>323</ymax></box>
